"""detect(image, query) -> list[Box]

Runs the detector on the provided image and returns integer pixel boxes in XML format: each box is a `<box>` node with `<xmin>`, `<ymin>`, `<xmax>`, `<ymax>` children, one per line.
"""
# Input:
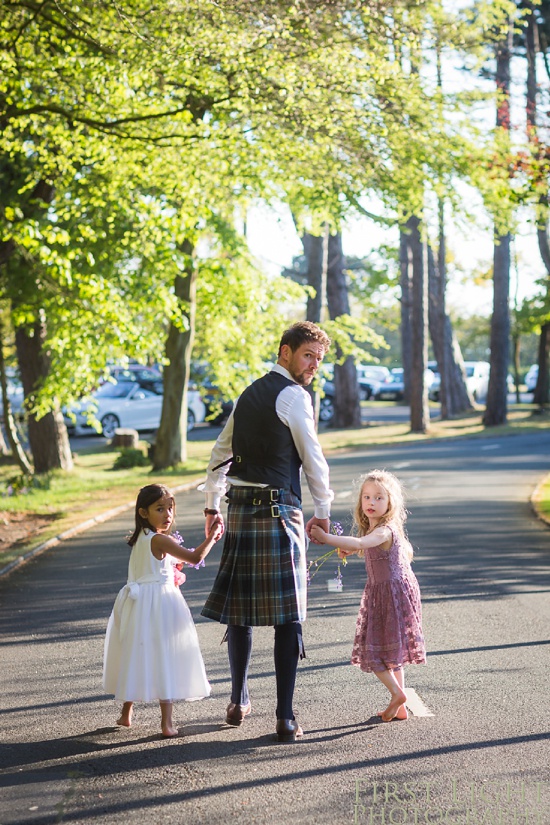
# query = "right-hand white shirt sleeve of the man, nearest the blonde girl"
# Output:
<box><xmin>276</xmin><ymin>385</ymin><xmax>334</xmax><ymax>518</ymax></box>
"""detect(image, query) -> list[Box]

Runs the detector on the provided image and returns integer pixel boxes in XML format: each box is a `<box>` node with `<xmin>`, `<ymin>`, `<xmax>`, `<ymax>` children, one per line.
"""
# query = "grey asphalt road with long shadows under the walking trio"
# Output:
<box><xmin>0</xmin><ymin>433</ymin><xmax>550</xmax><ymax>825</ymax></box>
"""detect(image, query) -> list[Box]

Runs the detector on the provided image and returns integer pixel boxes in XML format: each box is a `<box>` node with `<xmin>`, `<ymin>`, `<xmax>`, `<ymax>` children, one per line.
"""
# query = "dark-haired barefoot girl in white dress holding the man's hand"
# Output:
<box><xmin>103</xmin><ymin>484</ymin><xmax>223</xmax><ymax>736</ymax></box>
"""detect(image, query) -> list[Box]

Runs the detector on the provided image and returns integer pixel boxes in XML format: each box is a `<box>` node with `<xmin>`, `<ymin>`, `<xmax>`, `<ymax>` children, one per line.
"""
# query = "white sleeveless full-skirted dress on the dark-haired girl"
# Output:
<box><xmin>103</xmin><ymin>530</ymin><xmax>211</xmax><ymax>702</ymax></box>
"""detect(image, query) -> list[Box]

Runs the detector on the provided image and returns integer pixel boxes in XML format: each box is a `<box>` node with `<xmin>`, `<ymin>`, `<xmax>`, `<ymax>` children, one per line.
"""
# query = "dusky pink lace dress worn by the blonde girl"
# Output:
<box><xmin>351</xmin><ymin>525</ymin><xmax>426</xmax><ymax>673</ymax></box>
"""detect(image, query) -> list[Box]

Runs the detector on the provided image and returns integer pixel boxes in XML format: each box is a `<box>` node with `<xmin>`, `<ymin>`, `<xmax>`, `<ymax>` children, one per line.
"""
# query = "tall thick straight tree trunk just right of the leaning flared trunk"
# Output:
<box><xmin>483</xmin><ymin>23</ymin><xmax>513</xmax><ymax>427</ymax></box>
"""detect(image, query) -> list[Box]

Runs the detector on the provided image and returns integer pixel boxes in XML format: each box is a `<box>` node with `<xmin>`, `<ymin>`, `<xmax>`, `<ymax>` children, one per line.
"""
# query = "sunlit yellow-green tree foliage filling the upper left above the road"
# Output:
<box><xmin>0</xmin><ymin>0</ymin><xmax>512</xmax><ymax>438</ymax></box>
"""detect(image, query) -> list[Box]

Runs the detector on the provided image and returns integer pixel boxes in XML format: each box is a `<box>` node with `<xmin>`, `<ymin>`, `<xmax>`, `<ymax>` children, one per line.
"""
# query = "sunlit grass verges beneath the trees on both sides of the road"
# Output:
<box><xmin>0</xmin><ymin>405</ymin><xmax>550</xmax><ymax>569</ymax></box>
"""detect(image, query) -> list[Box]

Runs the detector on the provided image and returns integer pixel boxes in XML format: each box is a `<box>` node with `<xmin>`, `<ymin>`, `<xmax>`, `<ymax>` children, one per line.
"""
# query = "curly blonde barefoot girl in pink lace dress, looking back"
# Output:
<box><xmin>311</xmin><ymin>470</ymin><xmax>426</xmax><ymax>722</ymax></box>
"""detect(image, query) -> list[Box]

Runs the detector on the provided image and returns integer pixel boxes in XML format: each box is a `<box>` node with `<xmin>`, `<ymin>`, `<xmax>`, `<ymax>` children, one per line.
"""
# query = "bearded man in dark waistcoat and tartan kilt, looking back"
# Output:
<box><xmin>202</xmin><ymin>321</ymin><xmax>333</xmax><ymax>741</ymax></box>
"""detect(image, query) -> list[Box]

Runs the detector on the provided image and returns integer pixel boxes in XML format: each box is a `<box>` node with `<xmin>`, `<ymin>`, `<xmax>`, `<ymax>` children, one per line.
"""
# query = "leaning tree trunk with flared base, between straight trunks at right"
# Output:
<box><xmin>428</xmin><ymin>243</ymin><xmax>474</xmax><ymax>420</ymax></box>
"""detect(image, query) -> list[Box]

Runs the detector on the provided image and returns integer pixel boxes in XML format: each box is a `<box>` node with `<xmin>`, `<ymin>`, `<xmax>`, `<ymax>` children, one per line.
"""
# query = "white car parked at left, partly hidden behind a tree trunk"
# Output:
<box><xmin>65</xmin><ymin>381</ymin><xmax>206</xmax><ymax>438</ymax></box>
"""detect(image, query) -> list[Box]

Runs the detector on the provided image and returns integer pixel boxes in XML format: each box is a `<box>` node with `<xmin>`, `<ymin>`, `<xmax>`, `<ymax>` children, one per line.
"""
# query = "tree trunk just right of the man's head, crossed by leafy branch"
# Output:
<box><xmin>327</xmin><ymin>233</ymin><xmax>361</xmax><ymax>427</ymax></box>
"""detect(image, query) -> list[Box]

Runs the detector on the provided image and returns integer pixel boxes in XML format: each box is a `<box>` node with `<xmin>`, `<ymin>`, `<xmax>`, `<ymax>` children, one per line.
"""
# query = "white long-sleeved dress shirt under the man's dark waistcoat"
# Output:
<box><xmin>200</xmin><ymin>364</ymin><xmax>334</xmax><ymax>519</ymax></box>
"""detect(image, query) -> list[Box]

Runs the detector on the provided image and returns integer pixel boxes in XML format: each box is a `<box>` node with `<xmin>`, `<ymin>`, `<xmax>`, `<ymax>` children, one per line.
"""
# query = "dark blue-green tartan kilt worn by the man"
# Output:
<box><xmin>201</xmin><ymin>487</ymin><xmax>307</xmax><ymax>626</ymax></box>
